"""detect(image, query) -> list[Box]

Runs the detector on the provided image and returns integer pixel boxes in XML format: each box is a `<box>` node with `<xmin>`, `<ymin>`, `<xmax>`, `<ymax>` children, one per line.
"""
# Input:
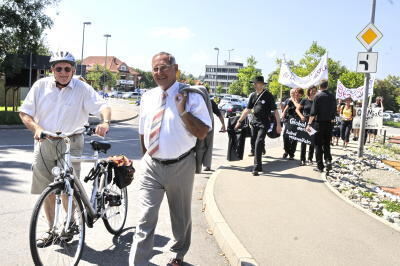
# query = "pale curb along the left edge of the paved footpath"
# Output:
<box><xmin>203</xmin><ymin>169</ymin><xmax>258</xmax><ymax>266</ymax></box>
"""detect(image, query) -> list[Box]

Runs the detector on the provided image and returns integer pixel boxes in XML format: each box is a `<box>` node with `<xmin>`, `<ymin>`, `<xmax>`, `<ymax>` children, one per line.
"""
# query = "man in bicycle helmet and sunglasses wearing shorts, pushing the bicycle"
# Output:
<box><xmin>19</xmin><ymin>52</ymin><xmax>111</xmax><ymax>247</ymax></box>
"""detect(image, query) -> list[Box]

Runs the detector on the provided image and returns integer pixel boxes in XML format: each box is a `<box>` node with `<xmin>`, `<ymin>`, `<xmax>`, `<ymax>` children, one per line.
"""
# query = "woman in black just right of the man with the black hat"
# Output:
<box><xmin>282</xmin><ymin>88</ymin><xmax>304</xmax><ymax>160</ymax></box>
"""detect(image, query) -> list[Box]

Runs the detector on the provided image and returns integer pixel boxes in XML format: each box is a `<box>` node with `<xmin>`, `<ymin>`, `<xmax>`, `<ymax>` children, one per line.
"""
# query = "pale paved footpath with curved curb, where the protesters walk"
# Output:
<box><xmin>205</xmin><ymin>140</ymin><xmax>400</xmax><ymax>265</ymax></box>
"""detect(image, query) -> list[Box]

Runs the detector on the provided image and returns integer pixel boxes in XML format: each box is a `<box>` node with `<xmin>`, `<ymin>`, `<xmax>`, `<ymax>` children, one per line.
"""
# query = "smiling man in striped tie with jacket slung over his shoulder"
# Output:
<box><xmin>129</xmin><ymin>52</ymin><xmax>212</xmax><ymax>266</ymax></box>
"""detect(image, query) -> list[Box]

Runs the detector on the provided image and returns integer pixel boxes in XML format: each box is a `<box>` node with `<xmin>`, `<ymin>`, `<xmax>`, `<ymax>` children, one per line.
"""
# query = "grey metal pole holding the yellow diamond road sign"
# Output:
<box><xmin>357</xmin><ymin>0</ymin><xmax>376</xmax><ymax>157</ymax></box>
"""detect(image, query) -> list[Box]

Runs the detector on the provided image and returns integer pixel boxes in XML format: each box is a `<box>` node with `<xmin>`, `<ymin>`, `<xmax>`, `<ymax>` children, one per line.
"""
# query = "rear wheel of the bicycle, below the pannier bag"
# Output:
<box><xmin>102</xmin><ymin>183</ymin><xmax>128</xmax><ymax>235</ymax></box>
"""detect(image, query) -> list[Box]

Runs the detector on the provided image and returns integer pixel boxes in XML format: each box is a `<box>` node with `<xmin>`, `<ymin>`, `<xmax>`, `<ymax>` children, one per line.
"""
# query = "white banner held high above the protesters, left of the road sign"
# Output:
<box><xmin>278</xmin><ymin>54</ymin><xmax>328</xmax><ymax>89</ymax></box>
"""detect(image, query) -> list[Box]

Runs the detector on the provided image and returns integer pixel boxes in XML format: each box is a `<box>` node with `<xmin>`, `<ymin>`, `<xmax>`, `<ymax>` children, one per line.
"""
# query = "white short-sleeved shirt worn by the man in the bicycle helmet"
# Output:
<box><xmin>19</xmin><ymin>77</ymin><xmax>108</xmax><ymax>133</ymax></box>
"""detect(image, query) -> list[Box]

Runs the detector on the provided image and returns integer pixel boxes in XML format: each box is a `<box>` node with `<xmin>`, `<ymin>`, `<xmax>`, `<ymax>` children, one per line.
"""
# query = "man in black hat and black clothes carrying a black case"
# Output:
<box><xmin>235</xmin><ymin>76</ymin><xmax>282</xmax><ymax>175</ymax></box>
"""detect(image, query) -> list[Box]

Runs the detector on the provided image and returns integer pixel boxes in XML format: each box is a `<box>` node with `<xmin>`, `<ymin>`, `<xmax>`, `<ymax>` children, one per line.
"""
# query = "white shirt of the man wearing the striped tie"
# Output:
<box><xmin>139</xmin><ymin>82</ymin><xmax>212</xmax><ymax>159</ymax></box>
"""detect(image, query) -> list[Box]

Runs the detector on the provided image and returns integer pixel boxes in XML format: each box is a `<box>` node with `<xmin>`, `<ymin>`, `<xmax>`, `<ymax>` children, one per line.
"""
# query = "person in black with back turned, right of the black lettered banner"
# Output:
<box><xmin>307</xmin><ymin>81</ymin><xmax>336</xmax><ymax>172</ymax></box>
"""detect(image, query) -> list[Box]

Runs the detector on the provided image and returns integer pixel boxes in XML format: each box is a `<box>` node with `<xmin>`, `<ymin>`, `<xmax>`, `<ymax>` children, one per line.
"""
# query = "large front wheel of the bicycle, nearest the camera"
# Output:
<box><xmin>29</xmin><ymin>184</ymin><xmax>85</xmax><ymax>265</ymax></box>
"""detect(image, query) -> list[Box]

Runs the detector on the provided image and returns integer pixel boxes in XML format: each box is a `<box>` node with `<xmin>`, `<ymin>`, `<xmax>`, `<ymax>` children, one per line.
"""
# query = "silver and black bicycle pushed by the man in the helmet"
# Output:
<box><xmin>29</xmin><ymin>127</ymin><xmax>128</xmax><ymax>265</ymax></box>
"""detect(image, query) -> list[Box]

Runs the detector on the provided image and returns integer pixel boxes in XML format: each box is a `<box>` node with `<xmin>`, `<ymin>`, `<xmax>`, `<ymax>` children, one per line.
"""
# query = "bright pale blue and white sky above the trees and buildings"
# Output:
<box><xmin>45</xmin><ymin>0</ymin><xmax>400</xmax><ymax>78</ymax></box>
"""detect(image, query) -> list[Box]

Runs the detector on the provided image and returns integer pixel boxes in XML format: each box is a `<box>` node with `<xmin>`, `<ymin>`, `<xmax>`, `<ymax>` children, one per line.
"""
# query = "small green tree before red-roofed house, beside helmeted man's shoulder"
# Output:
<box><xmin>86</xmin><ymin>65</ymin><xmax>119</xmax><ymax>90</ymax></box>
